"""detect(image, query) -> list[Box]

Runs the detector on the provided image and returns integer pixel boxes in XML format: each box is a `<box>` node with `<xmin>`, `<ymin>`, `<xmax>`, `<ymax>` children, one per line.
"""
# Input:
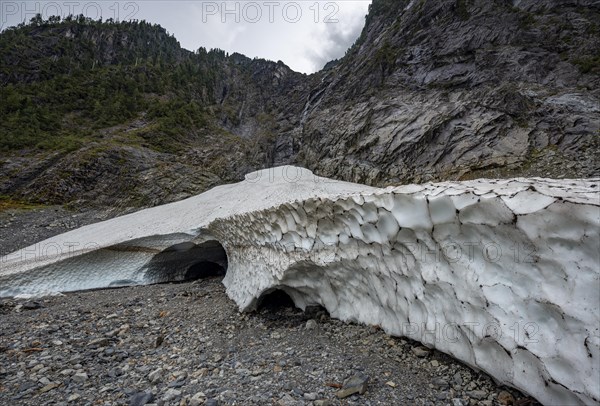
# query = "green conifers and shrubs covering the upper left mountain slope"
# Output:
<box><xmin>0</xmin><ymin>16</ymin><xmax>236</xmax><ymax>151</ymax></box>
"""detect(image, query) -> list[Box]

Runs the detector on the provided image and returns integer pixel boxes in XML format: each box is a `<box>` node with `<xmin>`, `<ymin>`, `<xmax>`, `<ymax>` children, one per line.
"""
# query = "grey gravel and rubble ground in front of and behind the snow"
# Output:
<box><xmin>0</xmin><ymin>207</ymin><xmax>536</xmax><ymax>406</ymax></box>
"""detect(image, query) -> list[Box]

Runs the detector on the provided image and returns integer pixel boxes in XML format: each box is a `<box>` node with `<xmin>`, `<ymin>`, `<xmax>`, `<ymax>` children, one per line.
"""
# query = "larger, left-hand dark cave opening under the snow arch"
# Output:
<box><xmin>146</xmin><ymin>240</ymin><xmax>227</xmax><ymax>283</ymax></box>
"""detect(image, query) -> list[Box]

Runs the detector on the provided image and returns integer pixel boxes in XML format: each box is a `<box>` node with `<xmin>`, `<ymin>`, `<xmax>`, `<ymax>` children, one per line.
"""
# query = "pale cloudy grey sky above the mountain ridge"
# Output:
<box><xmin>0</xmin><ymin>0</ymin><xmax>371</xmax><ymax>73</ymax></box>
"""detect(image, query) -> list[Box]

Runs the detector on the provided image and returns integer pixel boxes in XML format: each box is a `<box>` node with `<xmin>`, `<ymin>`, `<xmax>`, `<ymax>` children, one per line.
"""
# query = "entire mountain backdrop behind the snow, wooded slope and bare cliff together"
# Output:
<box><xmin>0</xmin><ymin>0</ymin><xmax>600</xmax><ymax>206</ymax></box>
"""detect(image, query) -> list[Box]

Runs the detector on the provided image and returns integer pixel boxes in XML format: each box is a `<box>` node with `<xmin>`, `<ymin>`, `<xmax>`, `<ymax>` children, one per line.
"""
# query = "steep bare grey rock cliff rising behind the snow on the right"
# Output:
<box><xmin>288</xmin><ymin>0</ymin><xmax>600</xmax><ymax>184</ymax></box>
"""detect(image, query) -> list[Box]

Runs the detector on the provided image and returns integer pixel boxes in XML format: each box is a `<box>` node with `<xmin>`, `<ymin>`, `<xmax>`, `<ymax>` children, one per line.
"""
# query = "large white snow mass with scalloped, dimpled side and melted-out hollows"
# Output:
<box><xmin>0</xmin><ymin>166</ymin><xmax>600</xmax><ymax>405</ymax></box>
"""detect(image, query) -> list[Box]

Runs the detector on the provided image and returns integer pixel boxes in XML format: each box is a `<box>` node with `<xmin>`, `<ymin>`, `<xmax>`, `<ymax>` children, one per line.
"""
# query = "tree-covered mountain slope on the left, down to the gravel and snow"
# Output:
<box><xmin>0</xmin><ymin>18</ymin><xmax>304</xmax><ymax>206</ymax></box>
